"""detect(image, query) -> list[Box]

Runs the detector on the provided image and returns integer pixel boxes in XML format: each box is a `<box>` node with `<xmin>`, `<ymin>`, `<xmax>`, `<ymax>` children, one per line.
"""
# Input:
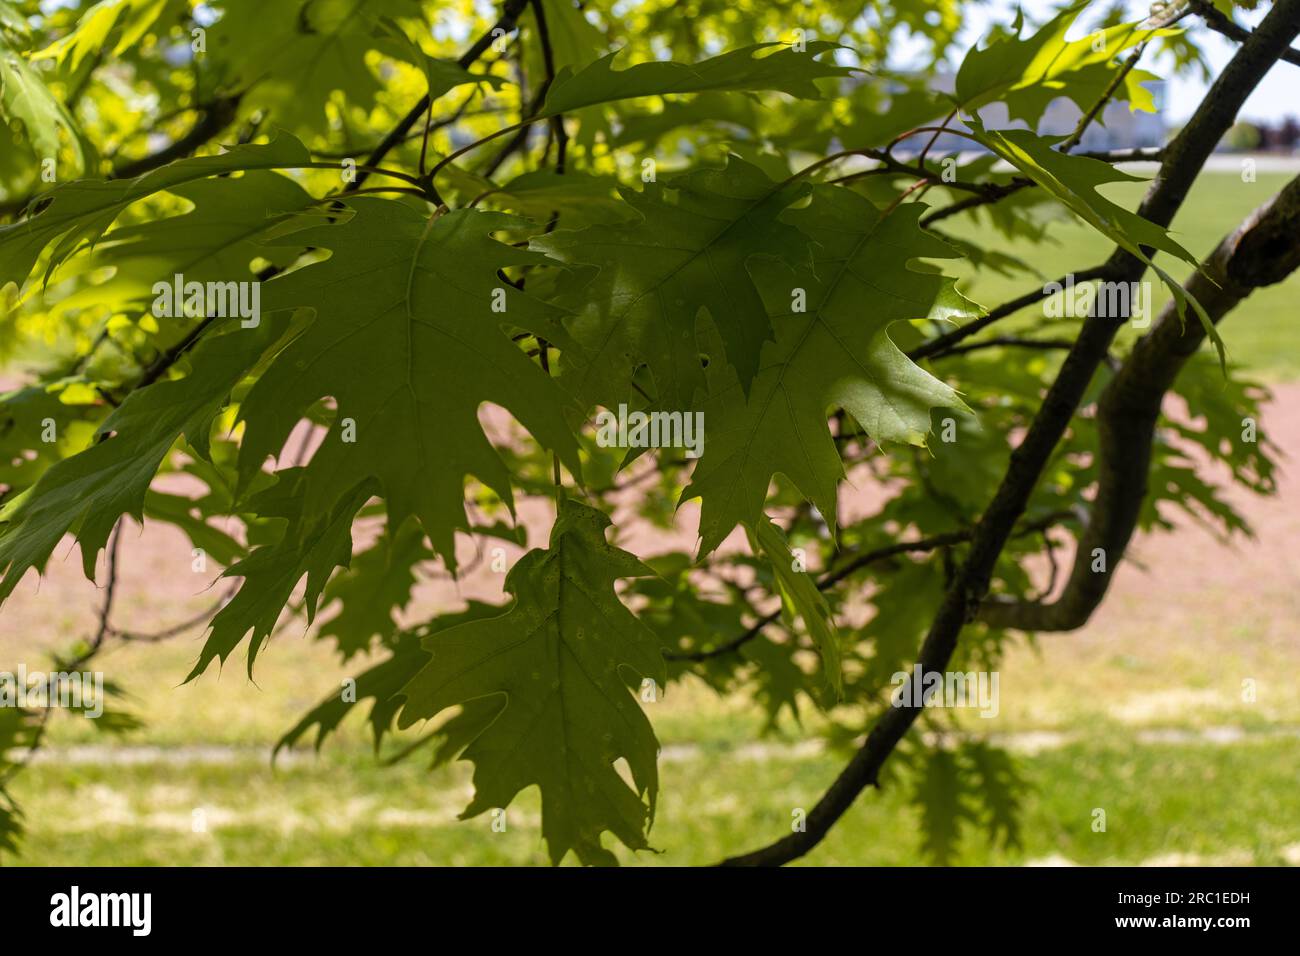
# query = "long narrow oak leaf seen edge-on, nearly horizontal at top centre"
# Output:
<box><xmin>536</xmin><ymin>40</ymin><xmax>854</xmax><ymax>120</ymax></box>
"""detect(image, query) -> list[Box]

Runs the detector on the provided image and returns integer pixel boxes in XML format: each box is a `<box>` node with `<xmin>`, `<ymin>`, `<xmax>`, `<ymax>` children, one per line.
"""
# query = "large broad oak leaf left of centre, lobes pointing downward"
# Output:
<box><xmin>239</xmin><ymin>196</ymin><xmax>581</xmax><ymax>563</ymax></box>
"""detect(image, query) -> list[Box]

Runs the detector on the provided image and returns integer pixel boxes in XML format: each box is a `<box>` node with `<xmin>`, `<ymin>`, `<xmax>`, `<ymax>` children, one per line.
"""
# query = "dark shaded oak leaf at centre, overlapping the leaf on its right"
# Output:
<box><xmin>533</xmin><ymin>156</ymin><xmax>809</xmax><ymax>408</ymax></box>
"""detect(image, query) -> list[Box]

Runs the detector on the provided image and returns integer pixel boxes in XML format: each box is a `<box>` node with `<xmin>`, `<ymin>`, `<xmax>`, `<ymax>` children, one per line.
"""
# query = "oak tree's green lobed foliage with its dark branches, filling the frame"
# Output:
<box><xmin>0</xmin><ymin>0</ymin><xmax>1300</xmax><ymax>864</ymax></box>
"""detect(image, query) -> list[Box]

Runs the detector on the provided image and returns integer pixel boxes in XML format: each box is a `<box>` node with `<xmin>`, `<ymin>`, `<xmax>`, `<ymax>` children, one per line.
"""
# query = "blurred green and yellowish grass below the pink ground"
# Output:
<box><xmin>13</xmin><ymin>620</ymin><xmax>1300</xmax><ymax>865</ymax></box>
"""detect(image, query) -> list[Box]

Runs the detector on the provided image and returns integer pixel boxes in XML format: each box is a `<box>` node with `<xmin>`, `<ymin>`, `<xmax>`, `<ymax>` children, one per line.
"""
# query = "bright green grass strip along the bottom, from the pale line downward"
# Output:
<box><xmin>16</xmin><ymin>734</ymin><xmax>1300</xmax><ymax>866</ymax></box>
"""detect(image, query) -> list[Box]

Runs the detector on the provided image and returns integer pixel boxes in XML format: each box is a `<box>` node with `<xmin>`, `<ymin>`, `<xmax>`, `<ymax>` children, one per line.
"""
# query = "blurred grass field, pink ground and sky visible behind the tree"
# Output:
<box><xmin>0</xmin><ymin>3</ymin><xmax>1300</xmax><ymax>865</ymax></box>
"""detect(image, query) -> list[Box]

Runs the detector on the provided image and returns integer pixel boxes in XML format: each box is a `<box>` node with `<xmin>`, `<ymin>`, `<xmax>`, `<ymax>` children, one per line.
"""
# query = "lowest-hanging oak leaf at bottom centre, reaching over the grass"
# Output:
<box><xmin>398</xmin><ymin>501</ymin><xmax>666</xmax><ymax>864</ymax></box>
